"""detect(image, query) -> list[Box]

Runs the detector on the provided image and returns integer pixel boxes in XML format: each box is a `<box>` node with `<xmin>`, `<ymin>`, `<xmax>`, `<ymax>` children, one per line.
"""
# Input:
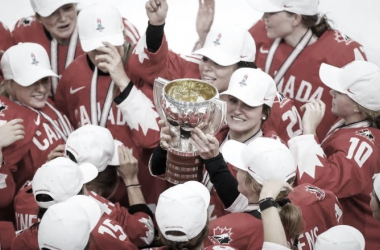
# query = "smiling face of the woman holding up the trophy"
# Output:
<box><xmin>225</xmin><ymin>95</ymin><xmax>264</xmax><ymax>142</ymax></box>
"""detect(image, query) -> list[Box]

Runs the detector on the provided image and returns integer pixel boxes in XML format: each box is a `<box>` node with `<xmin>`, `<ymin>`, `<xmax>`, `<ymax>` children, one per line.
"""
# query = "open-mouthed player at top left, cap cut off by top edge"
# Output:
<box><xmin>12</xmin><ymin>0</ymin><xmax>140</xmax><ymax>94</ymax></box>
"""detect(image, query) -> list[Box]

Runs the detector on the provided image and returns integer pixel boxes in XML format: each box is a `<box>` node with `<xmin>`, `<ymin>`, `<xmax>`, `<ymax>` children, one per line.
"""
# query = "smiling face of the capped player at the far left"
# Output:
<box><xmin>11</xmin><ymin>77</ymin><xmax>51</xmax><ymax>109</ymax></box>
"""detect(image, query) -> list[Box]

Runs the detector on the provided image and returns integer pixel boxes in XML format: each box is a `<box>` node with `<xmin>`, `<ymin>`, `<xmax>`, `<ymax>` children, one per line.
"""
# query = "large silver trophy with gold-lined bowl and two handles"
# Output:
<box><xmin>153</xmin><ymin>78</ymin><xmax>226</xmax><ymax>184</ymax></box>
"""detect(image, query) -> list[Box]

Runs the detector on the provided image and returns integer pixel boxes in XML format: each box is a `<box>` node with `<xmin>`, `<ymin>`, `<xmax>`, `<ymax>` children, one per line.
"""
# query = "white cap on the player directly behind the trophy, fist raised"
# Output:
<box><xmin>193</xmin><ymin>26</ymin><xmax>256</xmax><ymax>66</ymax></box>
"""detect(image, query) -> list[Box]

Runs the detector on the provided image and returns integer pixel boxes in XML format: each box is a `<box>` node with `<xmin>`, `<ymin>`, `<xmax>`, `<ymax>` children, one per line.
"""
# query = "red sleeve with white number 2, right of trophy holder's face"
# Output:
<box><xmin>263</xmin><ymin>92</ymin><xmax>302</xmax><ymax>143</ymax></box>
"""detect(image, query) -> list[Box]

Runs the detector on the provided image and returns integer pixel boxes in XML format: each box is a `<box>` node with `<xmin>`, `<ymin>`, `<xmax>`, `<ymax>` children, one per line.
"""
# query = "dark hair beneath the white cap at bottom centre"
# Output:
<box><xmin>158</xmin><ymin>220</ymin><xmax>208</xmax><ymax>250</ymax></box>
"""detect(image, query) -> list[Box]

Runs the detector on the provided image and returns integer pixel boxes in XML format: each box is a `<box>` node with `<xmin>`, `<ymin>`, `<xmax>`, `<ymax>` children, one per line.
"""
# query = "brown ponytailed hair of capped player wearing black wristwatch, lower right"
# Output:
<box><xmin>245</xmin><ymin>172</ymin><xmax>303</xmax><ymax>249</ymax></box>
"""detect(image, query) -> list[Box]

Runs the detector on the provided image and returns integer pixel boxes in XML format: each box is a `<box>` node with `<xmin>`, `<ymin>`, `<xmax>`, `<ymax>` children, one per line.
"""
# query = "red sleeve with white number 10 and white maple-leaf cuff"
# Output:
<box><xmin>289</xmin><ymin>133</ymin><xmax>379</xmax><ymax>198</ymax></box>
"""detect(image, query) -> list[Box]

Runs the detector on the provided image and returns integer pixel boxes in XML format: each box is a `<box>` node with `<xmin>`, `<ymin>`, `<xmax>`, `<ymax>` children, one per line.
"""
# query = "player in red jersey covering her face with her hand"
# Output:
<box><xmin>55</xmin><ymin>4</ymin><xmax>166</xmax><ymax>211</ymax></box>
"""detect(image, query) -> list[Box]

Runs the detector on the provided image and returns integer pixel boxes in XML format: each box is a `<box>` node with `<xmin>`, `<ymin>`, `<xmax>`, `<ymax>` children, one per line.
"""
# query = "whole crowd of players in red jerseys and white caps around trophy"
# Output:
<box><xmin>0</xmin><ymin>0</ymin><xmax>380</xmax><ymax>250</ymax></box>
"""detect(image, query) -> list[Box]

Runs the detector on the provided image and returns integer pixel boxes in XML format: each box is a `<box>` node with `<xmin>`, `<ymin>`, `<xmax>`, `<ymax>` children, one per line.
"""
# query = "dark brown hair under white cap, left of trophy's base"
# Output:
<box><xmin>86</xmin><ymin>166</ymin><xmax>119</xmax><ymax>199</ymax></box>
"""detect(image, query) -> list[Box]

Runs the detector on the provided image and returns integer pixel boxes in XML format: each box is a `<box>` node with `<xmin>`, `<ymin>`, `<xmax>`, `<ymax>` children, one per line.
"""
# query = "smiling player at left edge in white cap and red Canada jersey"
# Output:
<box><xmin>0</xmin><ymin>43</ymin><xmax>72</xmax><ymax>220</ymax></box>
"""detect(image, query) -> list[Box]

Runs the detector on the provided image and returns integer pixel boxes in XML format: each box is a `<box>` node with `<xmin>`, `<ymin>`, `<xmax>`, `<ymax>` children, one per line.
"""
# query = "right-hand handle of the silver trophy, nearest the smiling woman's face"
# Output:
<box><xmin>204</xmin><ymin>98</ymin><xmax>227</xmax><ymax>135</ymax></box>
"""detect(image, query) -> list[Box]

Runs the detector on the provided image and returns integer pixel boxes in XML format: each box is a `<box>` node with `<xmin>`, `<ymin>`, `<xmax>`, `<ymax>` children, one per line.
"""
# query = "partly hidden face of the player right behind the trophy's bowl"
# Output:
<box><xmin>199</xmin><ymin>57</ymin><xmax>238</xmax><ymax>93</ymax></box>
